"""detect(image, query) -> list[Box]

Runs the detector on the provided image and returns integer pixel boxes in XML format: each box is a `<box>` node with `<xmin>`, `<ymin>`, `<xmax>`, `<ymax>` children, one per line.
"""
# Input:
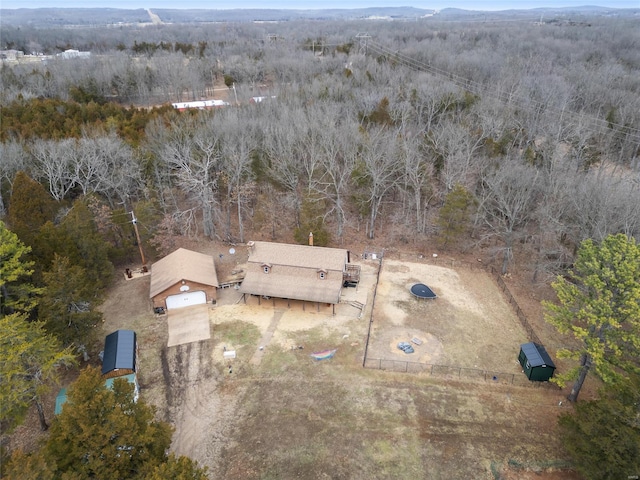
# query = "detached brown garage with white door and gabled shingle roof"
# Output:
<box><xmin>149</xmin><ymin>248</ymin><xmax>218</xmax><ymax>311</ymax></box>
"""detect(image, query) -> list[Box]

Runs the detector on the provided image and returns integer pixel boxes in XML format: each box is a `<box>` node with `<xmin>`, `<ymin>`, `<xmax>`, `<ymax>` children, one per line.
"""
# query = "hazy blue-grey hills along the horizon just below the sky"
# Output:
<box><xmin>0</xmin><ymin>5</ymin><xmax>640</xmax><ymax>27</ymax></box>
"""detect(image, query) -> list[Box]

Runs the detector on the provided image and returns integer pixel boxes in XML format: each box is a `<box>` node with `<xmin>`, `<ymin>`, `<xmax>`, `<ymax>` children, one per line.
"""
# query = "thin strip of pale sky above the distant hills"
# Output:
<box><xmin>5</xmin><ymin>0</ymin><xmax>640</xmax><ymax>10</ymax></box>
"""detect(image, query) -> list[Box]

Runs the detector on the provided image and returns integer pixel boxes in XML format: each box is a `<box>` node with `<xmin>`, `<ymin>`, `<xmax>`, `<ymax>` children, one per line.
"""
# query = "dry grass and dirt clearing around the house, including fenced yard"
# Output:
<box><xmin>86</xmin><ymin>244</ymin><xmax>578</xmax><ymax>480</ymax></box>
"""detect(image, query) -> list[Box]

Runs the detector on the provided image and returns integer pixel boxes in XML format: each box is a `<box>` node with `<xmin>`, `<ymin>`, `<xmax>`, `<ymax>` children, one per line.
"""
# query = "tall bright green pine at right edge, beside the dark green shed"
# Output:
<box><xmin>544</xmin><ymin>234</ymin><xmax>640</xmax><ymax>401</ymax></box>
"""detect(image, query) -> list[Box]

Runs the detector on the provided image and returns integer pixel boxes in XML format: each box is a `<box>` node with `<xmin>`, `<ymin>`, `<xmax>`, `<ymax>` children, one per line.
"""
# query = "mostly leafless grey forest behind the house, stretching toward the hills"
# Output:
<box><xmin>0</xmin><ymin>12</ymin><xmax>640</xmax><ymax>478</ymax></box>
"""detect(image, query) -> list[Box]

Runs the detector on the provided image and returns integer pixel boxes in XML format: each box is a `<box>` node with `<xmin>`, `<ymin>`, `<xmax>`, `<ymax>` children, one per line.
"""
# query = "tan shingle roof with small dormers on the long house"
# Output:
<box><xmin>240</xmin><ymin>242</ymin><xmax>349</xmax><ymax>305</ymax></box>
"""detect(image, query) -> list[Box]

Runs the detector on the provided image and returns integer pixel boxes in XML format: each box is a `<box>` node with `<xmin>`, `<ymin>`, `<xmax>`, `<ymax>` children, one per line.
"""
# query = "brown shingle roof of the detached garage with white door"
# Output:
<box><xmin>149</xmin><ymin>248</ymin><xmax>218</xmax><ymax>298</ymax></box>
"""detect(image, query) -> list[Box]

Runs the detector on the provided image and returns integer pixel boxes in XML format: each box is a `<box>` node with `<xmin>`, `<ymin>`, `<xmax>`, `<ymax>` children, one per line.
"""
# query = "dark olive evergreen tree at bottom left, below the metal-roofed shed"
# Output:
<box><xmin>43</xmin><ymin>368</ymin><xmax>172</xmax><ymax>479</ymax></box>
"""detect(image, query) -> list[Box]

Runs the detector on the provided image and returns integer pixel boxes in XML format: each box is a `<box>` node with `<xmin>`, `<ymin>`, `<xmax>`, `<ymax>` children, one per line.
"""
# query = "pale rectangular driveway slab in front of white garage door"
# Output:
<box><xmin>167</xmin><ymin>304</ymin><xmax>211</xmax><ymax>347</ymax></box>
